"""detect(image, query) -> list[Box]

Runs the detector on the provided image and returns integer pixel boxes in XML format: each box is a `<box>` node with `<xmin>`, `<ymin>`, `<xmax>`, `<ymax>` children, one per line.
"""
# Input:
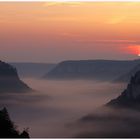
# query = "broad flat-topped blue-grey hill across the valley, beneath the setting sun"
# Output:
<box><xmin>44</xmin><ymin>60</ymin><xmax>140</xmax><ymax>81</ymax></box>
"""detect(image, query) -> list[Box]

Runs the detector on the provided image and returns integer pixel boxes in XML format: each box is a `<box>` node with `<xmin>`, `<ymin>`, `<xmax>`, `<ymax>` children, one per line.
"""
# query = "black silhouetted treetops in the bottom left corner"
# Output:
<box><xmin>0</xmin><ymin>108</ymin><xmax>29</xmax><ymax>138</ymax></box>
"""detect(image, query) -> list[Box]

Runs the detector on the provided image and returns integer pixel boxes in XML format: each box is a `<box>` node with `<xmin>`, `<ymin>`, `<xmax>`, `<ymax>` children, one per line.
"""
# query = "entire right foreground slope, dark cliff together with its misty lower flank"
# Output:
<box><xmin>76</xmin><ymin>71</ymin><xmax>140</xmax><ymax>138</ymax></box>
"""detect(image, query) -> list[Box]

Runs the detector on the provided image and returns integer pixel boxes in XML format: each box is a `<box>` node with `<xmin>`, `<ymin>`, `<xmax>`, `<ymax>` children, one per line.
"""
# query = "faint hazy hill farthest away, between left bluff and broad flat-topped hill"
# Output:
<box><xmin>10</xmin><ymin>62</ymin><xmax>55</xmax><ymax>78</ymax></box>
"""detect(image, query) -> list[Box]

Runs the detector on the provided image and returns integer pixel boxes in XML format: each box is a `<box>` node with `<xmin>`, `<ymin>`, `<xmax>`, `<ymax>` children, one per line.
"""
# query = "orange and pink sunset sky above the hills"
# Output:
<box><xmin>0</xmin><ymin>2</ymin><xmax>140</xmax><ymax>63</ymax></box>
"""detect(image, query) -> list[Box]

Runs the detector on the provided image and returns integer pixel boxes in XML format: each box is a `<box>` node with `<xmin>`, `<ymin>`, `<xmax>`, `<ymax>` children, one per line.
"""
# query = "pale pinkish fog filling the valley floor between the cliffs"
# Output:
<box><xmin>0</xmin><ymin>79</ymin><xmax>126</xmax><ymax>138</ymax></box>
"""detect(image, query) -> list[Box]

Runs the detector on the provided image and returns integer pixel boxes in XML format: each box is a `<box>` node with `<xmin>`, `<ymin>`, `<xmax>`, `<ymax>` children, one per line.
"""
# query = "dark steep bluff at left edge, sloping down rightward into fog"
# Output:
<box><xmin>0</xmin><ymin>61</ymin><xmax>31</xmax><ymax>93</ymax></box>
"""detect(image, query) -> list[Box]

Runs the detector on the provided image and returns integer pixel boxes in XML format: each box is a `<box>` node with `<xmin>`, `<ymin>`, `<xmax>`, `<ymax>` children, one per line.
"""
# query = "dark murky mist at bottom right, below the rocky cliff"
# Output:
<box><xmin>74</xmin><ymin>107</ymin><xmax>140</xmax><ymax>138</ymax></box>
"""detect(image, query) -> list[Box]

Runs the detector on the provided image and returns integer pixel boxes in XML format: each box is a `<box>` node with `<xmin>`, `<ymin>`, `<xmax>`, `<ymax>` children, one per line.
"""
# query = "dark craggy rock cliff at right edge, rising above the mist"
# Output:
<box><xmin>107</xmin><ymin>71</ymin><xmax>140</xmax><ymax>108</ymax></box>
